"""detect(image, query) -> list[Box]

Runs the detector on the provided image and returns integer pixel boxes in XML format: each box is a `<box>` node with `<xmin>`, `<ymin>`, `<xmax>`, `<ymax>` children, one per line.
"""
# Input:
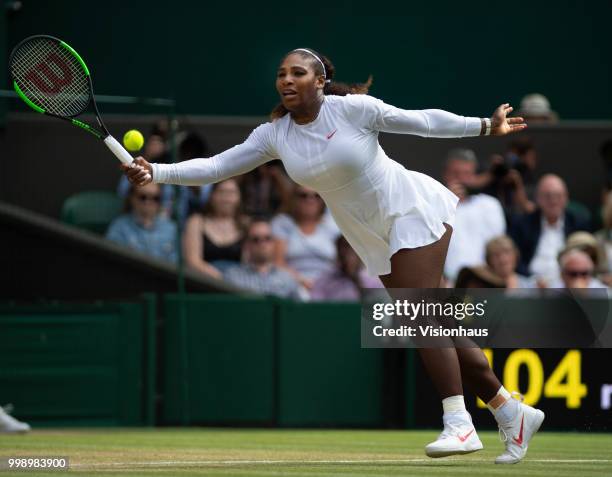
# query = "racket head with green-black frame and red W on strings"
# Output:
<box><xmin>9</xmin><ymin>35</ymin><xmax>93</xmax><ymax>119</ymax></box>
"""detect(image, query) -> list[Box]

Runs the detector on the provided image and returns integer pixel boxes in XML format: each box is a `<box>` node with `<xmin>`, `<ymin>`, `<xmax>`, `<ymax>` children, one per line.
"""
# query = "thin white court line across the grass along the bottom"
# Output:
<box><xmin>70</xmin><ymin>458</ymin><xmax>612</xmax><ymax>468</ymax></box>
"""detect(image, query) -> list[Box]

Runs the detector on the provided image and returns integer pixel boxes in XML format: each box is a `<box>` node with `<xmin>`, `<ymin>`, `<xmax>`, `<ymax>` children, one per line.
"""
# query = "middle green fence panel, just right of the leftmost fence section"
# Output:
<box><xmin>162</xmin><ymin>295</ymin><xmax>276</xmax><ymax>425</ymax></box>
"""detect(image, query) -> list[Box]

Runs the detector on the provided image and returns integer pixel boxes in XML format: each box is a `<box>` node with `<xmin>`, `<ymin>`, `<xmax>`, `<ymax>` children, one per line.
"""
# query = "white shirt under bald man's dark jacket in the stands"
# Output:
<box><xmin>529</xmin><ymin>217</ymin><xmax>565</xmax><ymax>283</ymax></box>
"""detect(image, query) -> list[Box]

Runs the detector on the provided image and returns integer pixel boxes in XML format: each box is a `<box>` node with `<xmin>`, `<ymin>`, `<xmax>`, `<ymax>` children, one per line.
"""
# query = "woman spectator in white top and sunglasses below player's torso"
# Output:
<box><xmin>272</xmin><ymin>185</ymin><xmax>340</xmax><ymax>290</ymax></box>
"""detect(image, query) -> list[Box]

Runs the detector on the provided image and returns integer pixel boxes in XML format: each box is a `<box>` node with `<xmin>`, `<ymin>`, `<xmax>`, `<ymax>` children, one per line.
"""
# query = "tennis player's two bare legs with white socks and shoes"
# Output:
<box><xmin>381</xmin><ymin>226</ymin><xmax>544</xmax><ymax>464</ymax></box>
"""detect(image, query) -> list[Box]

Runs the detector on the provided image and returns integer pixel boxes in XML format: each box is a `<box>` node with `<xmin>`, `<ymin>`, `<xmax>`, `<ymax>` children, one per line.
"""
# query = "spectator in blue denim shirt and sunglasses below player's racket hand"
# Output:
<box><xmin>106</xmin><ymin>183</ymin><xmax>177</xmax><ymax>263</ymax></box>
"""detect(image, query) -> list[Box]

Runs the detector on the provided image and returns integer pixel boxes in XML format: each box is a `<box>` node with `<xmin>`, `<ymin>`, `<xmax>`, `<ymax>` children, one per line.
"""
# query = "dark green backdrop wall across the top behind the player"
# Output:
<box><xmin>0</xmin><ymin>0</ymin><xmax>612</xmax><ymax>119</ymax></box>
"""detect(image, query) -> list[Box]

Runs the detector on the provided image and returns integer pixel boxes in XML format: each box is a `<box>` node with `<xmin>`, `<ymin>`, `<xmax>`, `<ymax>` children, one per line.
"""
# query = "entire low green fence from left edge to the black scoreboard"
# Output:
<box><xmin>0</xmin><ymin>295</ymin><xmax>383</xmax><ymax>427</ymax></box>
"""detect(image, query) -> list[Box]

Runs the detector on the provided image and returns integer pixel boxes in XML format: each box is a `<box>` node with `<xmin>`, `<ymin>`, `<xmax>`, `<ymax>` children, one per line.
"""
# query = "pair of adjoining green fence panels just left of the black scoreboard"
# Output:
<box><xmin>162</xmin><ymin>295</ymin><xmax>382</xmax><ymax>427</ymax></box>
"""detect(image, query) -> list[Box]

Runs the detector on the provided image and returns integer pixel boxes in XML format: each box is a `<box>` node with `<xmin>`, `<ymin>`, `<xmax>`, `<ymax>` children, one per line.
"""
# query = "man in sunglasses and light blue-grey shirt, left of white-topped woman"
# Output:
<box><xmin>224</xmin><ymin>219</ymin><xmax>308</xmax><ymax>299</ymax></box>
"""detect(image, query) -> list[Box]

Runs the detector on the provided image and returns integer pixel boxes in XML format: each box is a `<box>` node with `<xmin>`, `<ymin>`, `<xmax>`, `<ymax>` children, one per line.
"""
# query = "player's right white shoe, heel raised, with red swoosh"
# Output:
<box><xmin>495</xmin><ymin>396</ymin><xmax>544</xmax><ymax>464</ymax></box>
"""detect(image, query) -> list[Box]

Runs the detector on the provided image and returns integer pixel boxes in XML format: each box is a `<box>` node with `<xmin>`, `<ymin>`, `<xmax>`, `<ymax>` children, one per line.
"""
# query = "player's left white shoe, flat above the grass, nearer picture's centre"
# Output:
<box><xmin>425</xmin><ymin>411</ymin><xmax>483</xmax><ymax>458</ymax></box>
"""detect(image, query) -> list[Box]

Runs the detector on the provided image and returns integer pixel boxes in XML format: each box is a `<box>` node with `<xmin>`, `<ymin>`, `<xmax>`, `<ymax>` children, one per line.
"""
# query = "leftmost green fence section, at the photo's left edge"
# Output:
<box><xmin>0</xmin><ymin>297</ymin><xmax>155</xmax><ymax>426</ymax></box>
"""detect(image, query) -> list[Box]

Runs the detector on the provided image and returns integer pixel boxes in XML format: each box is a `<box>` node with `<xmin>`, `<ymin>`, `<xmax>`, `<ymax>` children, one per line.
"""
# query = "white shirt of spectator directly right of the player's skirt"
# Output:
<box><xmin>444</xmin><ymin>194</ymin><xmax>506</xmax><ymax>280</ymax></box>
